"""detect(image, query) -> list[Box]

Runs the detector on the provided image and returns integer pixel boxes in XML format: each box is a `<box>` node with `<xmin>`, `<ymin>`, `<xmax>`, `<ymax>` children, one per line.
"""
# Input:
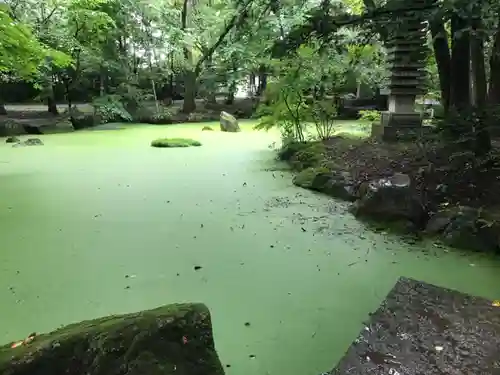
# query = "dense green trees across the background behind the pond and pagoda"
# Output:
<box><xmin>0</xmin><ymin>0</ymin><xmax>500</xmax><ymax>142</ymax></box>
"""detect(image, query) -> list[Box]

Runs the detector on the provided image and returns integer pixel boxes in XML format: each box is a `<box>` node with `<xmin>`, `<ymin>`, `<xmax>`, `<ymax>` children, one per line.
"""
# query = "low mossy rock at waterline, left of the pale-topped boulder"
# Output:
<box><xmin>293</xmin><ymin>167</ymin><xmax>356</xmax><ymax>201</ymax></box>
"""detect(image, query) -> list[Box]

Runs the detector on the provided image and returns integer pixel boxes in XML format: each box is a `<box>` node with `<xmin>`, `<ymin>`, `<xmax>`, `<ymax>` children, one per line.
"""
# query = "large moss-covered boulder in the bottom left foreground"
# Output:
<box><xmin>0</xmin><ymin>304</ymin><xmax>224</xmax><ymax>375</ymax></box>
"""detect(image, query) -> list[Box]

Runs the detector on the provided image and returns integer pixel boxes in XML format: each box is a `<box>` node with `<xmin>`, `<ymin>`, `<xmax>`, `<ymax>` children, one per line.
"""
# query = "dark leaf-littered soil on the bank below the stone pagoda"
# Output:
<box><xmin>325</xmin><ymin>137</ymin><xmax>500</xmax><ymax>210</ymax></box>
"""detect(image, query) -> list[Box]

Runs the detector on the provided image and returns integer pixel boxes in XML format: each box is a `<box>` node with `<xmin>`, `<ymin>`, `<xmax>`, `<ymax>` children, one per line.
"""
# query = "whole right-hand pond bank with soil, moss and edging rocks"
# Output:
<box><xmin>288</xmin><ymin>135</ymin><xmax>500</xmax><ymax>253</ymax></box>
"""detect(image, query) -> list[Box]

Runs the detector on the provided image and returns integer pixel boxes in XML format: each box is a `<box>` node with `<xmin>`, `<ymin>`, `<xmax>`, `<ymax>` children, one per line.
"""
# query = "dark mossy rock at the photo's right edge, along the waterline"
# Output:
<box><xmin>425</xmin><ymin>206</ymin><xmax>500</xmax><ymax>251</ymax></box>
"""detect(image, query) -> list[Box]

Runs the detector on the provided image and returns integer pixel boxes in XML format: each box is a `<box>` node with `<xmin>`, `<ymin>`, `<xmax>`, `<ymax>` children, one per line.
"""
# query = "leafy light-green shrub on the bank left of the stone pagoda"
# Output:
<box><xmin>256</xmin><ymin>42</ymin><xmax>346</xmax><ymax>142</ymax></box>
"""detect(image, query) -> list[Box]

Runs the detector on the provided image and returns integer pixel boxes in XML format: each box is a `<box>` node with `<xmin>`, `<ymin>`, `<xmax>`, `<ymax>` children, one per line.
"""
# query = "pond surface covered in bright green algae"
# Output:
<box><xmin>0</xmin><ymin>125</ymin><xmax>500</xmax><ymax>375</ymax></box>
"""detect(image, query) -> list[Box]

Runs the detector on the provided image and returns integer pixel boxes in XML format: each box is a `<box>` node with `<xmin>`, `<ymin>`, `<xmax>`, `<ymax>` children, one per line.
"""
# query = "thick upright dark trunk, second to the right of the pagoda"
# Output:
<box><xmin>450</xmin><ymin>14</ymin><xmax>471</xmax><ymax>112</ymax></box>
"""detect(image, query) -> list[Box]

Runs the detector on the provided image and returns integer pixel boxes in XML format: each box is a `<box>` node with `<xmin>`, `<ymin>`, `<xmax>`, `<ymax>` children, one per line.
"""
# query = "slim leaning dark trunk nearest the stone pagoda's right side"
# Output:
<box><xmin>430</xmin><ymin>18</ymin><xmax>451</xmax><ymax>114</ymax></box>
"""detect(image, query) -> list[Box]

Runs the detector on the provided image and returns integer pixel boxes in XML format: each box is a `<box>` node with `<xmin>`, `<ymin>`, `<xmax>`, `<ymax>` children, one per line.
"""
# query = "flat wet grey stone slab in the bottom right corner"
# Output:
<box><xmin>330</xmin><ymin>278</ymin><xmax>500</xmax><ymax>375</ymax></box>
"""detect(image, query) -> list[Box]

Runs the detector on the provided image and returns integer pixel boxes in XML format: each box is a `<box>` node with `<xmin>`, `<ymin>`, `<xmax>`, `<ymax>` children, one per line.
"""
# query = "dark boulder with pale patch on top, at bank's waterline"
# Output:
<box><xmin>351</xmin><ymin>173</ymin><xmax>426</xmax><ymax>226</ymax></box>
